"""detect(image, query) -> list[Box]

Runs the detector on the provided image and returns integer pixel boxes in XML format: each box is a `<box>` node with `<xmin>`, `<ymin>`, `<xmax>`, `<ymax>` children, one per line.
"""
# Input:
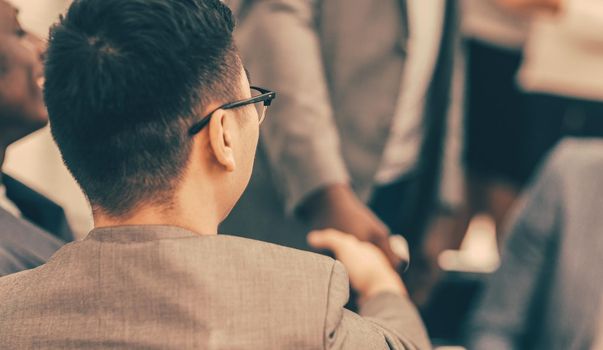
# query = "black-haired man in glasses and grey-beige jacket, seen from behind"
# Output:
<box><xmin>0</xmin><ymin>0</ymin><xmax>430</xmax><ymax>349</ymax></box>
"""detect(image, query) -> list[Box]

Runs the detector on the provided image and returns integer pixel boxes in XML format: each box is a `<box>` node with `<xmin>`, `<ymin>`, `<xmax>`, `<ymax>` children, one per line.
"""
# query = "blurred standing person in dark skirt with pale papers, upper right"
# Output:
<box><xmin>463</xmin><ymin>0</ymin><xmax>603</xmax><ymax>242</ymax></box>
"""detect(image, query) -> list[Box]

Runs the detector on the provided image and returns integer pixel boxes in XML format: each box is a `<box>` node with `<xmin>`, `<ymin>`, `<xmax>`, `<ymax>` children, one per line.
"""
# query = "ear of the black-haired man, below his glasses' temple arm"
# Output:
<box><xmin>208</xmin><ymin>109</ymin><xmax>236</xmax><ymax>172</ymax></box>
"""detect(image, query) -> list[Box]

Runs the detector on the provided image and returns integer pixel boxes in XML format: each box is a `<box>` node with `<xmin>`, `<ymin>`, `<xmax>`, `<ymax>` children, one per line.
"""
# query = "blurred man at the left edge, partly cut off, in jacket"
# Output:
<box><xmin>0</xmin><ymin>0</ymin><xmax>73</xmax><ymax>276</ymax></box>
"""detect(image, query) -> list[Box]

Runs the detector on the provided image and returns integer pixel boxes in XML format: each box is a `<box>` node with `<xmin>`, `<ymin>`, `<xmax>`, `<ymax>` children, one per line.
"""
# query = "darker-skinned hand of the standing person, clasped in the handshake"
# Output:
<box><xmin>300</xmin><ymin>184</ymin><xmax>401</xmax><ymax>268</ymax></box>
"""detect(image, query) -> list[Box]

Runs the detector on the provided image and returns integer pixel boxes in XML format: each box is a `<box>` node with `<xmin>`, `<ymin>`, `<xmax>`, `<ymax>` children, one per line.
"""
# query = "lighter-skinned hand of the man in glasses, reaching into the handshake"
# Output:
<box><xmin>308</xmin><ymin>229</ymin><xmax>407</xmax><ymax>300</ymax></box>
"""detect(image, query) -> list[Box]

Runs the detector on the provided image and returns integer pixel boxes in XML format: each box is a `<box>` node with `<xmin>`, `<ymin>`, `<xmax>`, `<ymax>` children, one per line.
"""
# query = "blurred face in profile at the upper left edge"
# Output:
<box><xmin>0</xmin><ymin>0</ymin><xmax>48</xmax><ymax>141</ymax></box>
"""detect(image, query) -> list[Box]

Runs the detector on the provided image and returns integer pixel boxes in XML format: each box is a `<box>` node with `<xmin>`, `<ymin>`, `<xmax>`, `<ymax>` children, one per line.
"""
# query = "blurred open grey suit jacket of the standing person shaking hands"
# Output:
<box><xmin>222</xmin><ymin>0</ymin><xmax>456</xmax><ymax>252</ymax></box>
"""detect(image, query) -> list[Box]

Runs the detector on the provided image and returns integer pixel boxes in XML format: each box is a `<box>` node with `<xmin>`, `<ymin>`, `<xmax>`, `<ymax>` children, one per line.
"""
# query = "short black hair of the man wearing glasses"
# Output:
<box><xmin>44</xmin><ymin>0</ymin><xmax>242</xmax><ymax>217</ymax></box>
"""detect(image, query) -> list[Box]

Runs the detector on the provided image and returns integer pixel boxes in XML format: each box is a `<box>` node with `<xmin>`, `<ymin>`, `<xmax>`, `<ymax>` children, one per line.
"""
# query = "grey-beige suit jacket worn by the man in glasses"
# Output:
<box><xmin>0</xmin><ymin>226</ymin><xmax>430</xmax><ymax>350</ymax></box>
